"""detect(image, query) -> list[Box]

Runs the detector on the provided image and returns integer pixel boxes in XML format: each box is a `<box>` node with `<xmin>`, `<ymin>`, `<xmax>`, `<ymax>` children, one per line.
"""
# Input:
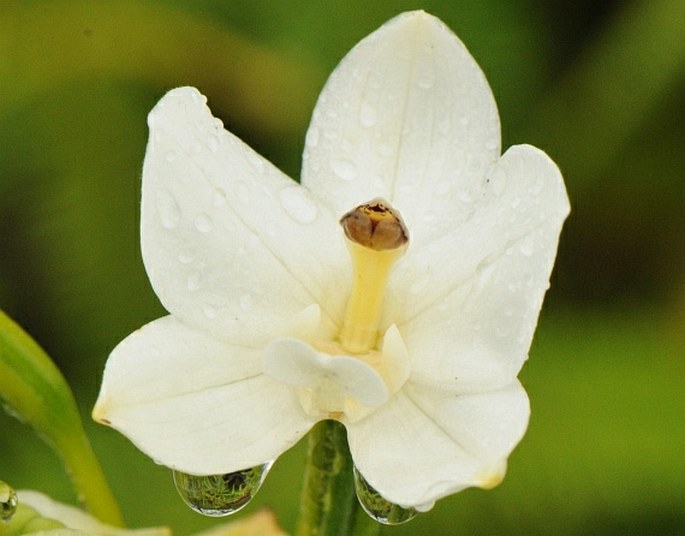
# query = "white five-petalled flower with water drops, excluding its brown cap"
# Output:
<box><xmin>93</xmin><ymin>11</ymin><xmax>569</xmax><ymax>508</ymax></box>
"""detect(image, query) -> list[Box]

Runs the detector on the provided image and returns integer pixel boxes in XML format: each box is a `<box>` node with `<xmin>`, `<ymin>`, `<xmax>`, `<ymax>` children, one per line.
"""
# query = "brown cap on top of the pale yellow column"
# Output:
<box><xmin>340</xmin><ymin>199</ymin><xmax>409</xmax><ymax>251</ymax></box>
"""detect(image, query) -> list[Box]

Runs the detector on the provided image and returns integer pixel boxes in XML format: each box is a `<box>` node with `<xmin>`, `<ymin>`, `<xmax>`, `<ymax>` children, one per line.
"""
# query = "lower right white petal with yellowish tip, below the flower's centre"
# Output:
<box><xmin>348</xmin><ymin>381</ymin><xmax>530</xmax><ymax>507</ymax></box>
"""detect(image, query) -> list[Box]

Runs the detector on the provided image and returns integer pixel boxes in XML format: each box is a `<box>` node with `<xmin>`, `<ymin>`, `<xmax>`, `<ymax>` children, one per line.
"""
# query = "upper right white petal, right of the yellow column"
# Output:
<box><xmin>386</xmin><ymin>146</ymin><xmax>569</xmax><ymax>391</ymax></box>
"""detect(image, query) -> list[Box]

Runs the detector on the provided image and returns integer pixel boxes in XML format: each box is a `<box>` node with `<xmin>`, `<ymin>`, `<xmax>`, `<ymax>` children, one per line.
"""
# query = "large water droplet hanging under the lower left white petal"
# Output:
<box><xmin>173</xmin><ymin>462</ymin><xmax>273</xmax><ymax>517</ymax></box>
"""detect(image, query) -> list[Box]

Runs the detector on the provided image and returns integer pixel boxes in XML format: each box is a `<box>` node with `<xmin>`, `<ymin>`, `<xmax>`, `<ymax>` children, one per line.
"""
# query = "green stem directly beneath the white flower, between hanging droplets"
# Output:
<box><xmin>296</xmin><ymin>421</ymin><xmax>380</xmax><ymax>536</ymax></box>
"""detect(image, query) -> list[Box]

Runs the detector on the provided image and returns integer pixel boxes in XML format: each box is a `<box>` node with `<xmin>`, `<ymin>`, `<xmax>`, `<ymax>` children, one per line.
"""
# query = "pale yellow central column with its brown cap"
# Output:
<box><xmin>339</xmin><ymin>199</ymin><xmax>409</xmax><ymax>354</ymax></box>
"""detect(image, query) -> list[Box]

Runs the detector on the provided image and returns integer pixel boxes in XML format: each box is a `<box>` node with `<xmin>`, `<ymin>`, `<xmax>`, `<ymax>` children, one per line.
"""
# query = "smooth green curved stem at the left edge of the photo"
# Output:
<box><xmin>0</xmin><ymin>311</ymin><xmax>124</xmax><ymax>526</ymax></box>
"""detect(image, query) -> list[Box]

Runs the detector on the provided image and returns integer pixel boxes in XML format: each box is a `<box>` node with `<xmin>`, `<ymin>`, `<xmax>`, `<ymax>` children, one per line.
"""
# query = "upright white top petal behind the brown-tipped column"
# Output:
<box><xmin>302</xmin><ymin>11</ymin><xmax>500</xmax><ymax>243</ymax></box>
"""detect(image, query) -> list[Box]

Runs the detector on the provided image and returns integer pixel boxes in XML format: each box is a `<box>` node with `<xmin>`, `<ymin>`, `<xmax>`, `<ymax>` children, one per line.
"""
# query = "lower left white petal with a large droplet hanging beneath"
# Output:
<box><xmin>93</xmin><ymin>317</ymin><xmax>312</xmax><ymax>474</ymax></box>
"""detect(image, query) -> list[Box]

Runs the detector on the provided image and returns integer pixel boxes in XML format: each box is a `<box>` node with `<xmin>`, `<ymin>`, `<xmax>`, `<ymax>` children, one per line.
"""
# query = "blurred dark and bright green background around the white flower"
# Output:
<box><xmin>0</xmin><ymin>0</ymin><xmax>685</xmax><ymax>535</ymax></box>
